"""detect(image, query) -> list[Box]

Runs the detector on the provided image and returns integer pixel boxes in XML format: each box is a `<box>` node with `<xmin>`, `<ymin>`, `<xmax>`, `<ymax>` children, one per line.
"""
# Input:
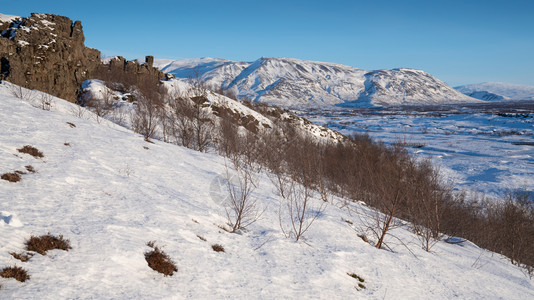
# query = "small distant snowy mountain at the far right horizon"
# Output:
<box><xmin>455</xmin><ymin>82</ymin><xmax>534</xmax><ymax>101</ymax></box>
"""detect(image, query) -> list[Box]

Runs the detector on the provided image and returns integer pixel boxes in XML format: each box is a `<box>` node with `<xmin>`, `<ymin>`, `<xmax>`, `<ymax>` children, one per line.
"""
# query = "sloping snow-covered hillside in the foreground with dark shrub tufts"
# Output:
<box><xmin>0</xmin><ymin>84</ymin><xmax>534</xmax><ymax>299</ymax></box>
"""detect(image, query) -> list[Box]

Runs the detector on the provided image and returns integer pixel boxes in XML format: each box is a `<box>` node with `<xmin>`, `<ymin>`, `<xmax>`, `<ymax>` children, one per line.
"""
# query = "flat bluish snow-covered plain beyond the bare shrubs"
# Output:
<box><xmin>298</xmin><ymin>102</ymin><xmax>534</xmax><ymax>197</ymax></box>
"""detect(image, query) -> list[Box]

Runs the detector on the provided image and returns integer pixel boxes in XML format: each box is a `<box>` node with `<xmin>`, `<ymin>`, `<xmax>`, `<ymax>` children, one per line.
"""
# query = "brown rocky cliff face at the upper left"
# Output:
<box><xmin>0</xmin><ymin>13</ymin><xmax>164</xmax><ymax>101</ymax></box>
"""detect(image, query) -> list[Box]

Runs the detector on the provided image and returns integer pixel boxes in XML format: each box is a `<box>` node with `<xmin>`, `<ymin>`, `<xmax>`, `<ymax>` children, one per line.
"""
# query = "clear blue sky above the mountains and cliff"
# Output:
<box><xmin>0</xmin><ymin>0</ymin><xmax>534</xmax><ymax>86</ymax></box>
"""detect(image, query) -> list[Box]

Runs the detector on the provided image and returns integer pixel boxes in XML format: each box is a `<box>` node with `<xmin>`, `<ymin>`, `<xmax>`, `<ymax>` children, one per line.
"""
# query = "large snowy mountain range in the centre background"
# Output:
<box><xmin>154</xmin><ymin>57</ymin><xmax>477</xmax><ymax>106</ymax></box>
